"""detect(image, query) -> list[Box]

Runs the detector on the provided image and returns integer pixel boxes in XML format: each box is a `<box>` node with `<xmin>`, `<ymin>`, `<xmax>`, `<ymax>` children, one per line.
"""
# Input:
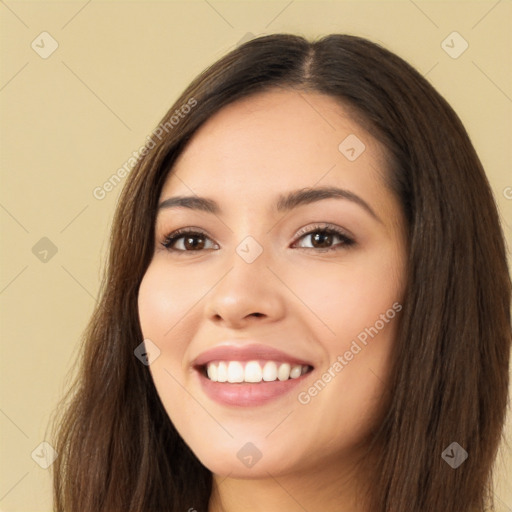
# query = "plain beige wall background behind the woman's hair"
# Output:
<box><xmin>0</xmin><ymin>0</ymin><xmax>512</xmax><ymax>512</ymax></box>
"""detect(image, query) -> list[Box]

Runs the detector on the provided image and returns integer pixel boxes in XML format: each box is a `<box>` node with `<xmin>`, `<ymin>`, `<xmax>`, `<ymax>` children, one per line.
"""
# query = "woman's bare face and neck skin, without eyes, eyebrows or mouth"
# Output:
<box><xmin>139</xmin><ymin>90</ymin><xmax>406</xmax><ymax>512</ymax></box>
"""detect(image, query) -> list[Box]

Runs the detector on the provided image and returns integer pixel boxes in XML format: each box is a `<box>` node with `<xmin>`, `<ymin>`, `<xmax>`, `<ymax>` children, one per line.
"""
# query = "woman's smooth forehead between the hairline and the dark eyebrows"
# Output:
<box><xmin>161</xmin><ymin>90</ymin><xmax>386</xmax><ymax>208</ymax></box>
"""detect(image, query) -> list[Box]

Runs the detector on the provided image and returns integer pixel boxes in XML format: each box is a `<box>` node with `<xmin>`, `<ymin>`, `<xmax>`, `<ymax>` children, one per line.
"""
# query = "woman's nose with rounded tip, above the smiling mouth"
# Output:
<box><xmin>205</xmin><ymin>247</ymin><xmax>285</xmax><ymax>328</ymax></box>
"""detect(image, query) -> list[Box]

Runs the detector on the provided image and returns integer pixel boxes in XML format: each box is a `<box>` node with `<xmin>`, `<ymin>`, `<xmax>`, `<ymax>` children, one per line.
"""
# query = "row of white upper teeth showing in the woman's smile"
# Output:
<box><xmin>206</xmin><ymin>361</ymin><xmax>310</xmax><ymax>383</ymax></box>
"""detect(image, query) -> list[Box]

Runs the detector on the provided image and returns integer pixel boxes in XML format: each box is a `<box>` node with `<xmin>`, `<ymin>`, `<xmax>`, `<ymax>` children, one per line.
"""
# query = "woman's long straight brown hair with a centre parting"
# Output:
<box><xmin>52</xmin><ymin>34</ymin><xmax>511</xmax><ymax>512</ymax></box>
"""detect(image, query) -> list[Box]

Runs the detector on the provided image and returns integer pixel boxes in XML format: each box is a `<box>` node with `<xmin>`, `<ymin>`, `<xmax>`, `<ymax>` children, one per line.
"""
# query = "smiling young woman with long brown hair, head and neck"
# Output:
<box><xmin>54</xmin><ymin>34</ymin><xmax>511</xmax><ymax>512</ymax></box>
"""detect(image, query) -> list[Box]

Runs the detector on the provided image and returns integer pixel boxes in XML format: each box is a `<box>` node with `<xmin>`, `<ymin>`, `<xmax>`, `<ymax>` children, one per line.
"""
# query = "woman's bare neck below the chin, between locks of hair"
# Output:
<box><xmin>208</xmin><ymin>454</ymin><xmax>368</xmax><ymax>512</ymax></box>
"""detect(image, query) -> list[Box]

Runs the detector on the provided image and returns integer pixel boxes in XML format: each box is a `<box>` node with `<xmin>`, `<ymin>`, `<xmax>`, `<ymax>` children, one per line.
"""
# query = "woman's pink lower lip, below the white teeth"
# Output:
<box><xmin>197</xmin><ymin>372</ymin><xmax>311</xmax><ymax>407</ymax></box>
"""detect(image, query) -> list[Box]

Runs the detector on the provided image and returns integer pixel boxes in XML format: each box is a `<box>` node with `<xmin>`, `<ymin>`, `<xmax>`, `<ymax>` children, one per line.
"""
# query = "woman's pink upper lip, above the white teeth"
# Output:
<box><xmin>191</xmin><ymin>342</ymin><xmax>313</xmax><ymax>366</ymax></box>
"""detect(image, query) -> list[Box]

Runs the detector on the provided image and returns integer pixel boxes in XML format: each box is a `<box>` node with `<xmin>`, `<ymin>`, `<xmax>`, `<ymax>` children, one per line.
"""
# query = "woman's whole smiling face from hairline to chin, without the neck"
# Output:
<box><xmin>138</xmin><ymin>90</ymin><xmax>406</xmax><ymax>478</ymax></box>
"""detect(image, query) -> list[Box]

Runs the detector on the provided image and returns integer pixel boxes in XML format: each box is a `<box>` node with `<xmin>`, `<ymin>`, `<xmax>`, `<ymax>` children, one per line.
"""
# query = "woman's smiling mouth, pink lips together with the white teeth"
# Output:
<box><xmin>192</xmin><ymin>346</ymin><xmax>314</xmax><ymax>407</ymax></box>
